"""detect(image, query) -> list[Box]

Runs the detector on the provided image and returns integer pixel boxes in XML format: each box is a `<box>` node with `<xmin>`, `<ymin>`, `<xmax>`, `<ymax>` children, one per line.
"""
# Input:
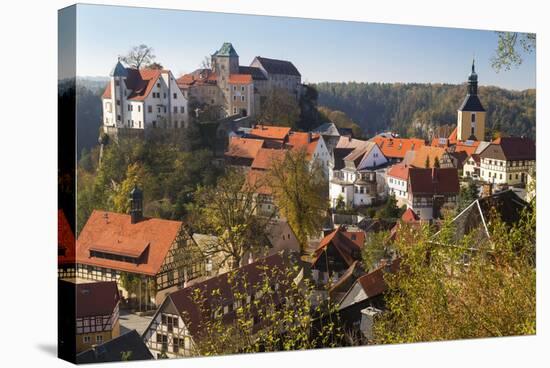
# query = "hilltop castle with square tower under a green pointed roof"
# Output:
<box><xmin>177</xmin><ymin>42</ymin><xmax>302</xmax><ymax>118</ymax></box>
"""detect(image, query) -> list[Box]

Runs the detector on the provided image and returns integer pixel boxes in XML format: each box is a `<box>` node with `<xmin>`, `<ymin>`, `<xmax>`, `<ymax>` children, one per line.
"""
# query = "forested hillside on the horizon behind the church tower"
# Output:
<box><xmin>314</xmin><ymin>82</ymin><xmax>536</xmax><ymax>138</ymax></box>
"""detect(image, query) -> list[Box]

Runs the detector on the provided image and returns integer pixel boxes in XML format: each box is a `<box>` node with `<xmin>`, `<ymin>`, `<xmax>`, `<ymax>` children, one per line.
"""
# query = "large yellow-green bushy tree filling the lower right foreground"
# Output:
<box><xmin>375</xmin><ymin>201</ymin><xmax>536</xmax><ymax>343</ymax></box>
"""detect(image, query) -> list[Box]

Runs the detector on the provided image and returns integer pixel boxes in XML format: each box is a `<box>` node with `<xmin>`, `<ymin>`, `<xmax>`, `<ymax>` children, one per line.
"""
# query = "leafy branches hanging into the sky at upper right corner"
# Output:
<box><xmin>491</xmin><ymin>32</ymin><xmax>536</xmax><ymax>72</ymax></box>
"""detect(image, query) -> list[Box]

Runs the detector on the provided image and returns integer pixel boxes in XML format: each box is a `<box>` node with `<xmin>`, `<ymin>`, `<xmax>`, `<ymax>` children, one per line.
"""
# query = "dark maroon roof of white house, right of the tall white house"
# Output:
<box><xmin>409</xmin><ymin>168</ymin><xmax>460</xmax><ymax>195</ymax></box>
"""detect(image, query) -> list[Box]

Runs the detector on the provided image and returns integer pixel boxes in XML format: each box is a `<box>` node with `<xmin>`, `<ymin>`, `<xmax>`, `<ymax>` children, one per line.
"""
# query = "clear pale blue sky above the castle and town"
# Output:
<box><xmin>70</xmin><ymin>5</ymin><xmax>536</xmax><ymax>90</ymax></box>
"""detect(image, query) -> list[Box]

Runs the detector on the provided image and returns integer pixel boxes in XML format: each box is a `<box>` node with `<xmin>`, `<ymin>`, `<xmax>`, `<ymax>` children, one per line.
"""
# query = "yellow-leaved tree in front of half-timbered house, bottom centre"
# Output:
<box><xmin>188</xmin><ymin>254</ymin><xmax>343</xmax><ymax>356</ymax></box>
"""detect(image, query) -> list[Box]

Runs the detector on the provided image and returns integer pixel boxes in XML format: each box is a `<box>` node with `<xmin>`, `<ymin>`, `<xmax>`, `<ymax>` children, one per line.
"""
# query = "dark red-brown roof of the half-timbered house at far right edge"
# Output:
<box><xmin>480</xmin><ymin>137</ymin><xmax>537</xmax><ymax>161</ymax></box>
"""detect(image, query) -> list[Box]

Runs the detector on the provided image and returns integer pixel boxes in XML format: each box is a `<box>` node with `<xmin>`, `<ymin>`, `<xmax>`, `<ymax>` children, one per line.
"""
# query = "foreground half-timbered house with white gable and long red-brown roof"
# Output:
<box><xmin>142</xmin><ymin>253</ymin><xmax>298</xmax><ymax>358</ymax></box>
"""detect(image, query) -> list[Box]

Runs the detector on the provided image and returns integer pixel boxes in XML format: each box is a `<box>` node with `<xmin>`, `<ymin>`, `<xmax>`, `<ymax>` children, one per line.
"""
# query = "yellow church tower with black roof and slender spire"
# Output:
<box><xmin>457</xmin><ymin>61</ymin><xmax>486</xmax><ymax>141</ymax></box>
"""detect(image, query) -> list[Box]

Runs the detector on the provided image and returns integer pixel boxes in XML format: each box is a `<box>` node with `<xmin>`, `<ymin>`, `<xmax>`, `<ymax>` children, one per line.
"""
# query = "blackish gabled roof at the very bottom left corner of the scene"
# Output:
<box><xmin>76</xmin><ymin>330</ymin><xmax>154</xmax><ymax>364</ymax></box>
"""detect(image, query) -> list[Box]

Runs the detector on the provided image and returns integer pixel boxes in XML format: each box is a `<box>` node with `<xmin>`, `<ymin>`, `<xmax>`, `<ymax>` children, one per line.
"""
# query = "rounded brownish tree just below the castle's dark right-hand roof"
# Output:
<box><xmin>258</xmin><ymin>88</ymin><xmax>300</xmax><ymax>127</ymax></box>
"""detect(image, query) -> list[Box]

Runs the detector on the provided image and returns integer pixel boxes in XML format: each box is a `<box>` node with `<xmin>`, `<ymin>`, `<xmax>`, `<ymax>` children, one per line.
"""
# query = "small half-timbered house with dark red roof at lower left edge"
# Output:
<box><xmin>68</xmin><ymin>281</ymin><xmax>120</xmax><ymax>353</ymax></box>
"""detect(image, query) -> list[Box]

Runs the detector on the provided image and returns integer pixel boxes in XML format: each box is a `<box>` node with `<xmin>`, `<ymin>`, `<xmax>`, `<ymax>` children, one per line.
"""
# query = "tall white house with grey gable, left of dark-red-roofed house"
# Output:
<box><xmin>329</xmin><ymin>137</ymin><xmax>388</xmax><ymax>208</ymax></box>
